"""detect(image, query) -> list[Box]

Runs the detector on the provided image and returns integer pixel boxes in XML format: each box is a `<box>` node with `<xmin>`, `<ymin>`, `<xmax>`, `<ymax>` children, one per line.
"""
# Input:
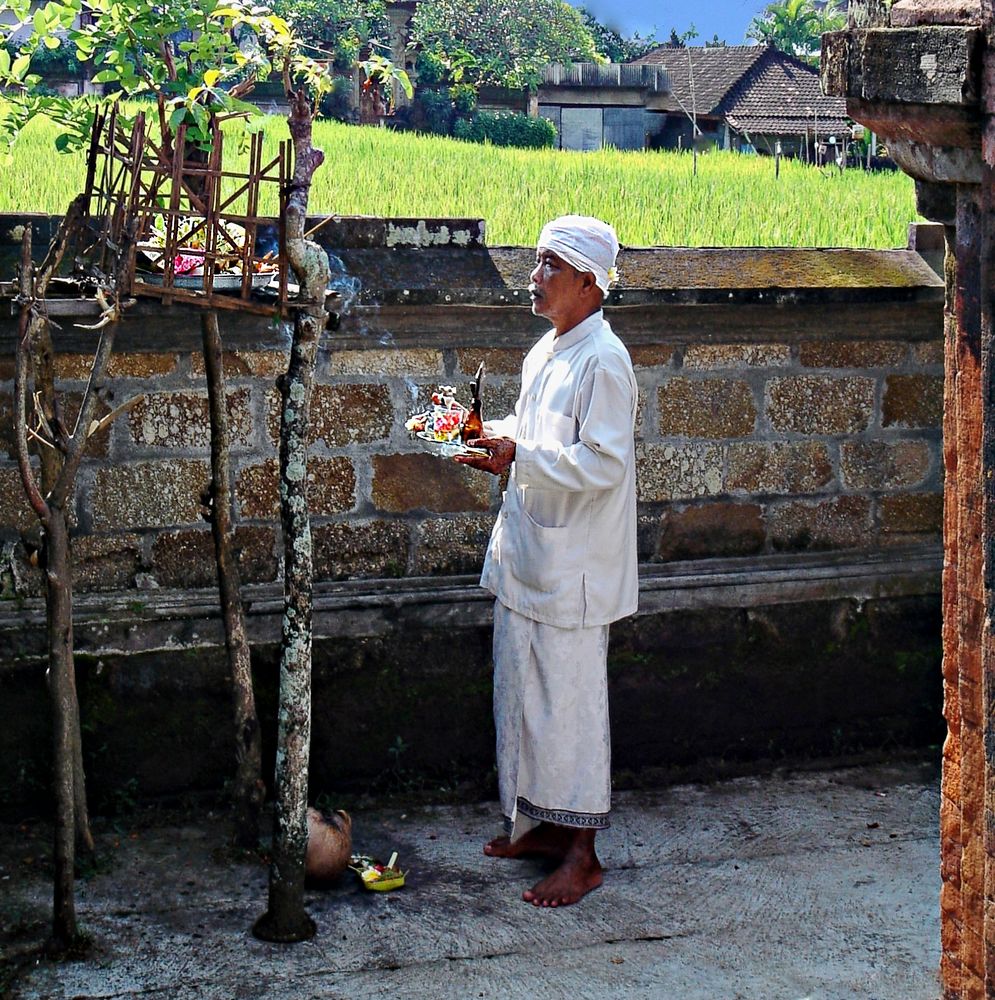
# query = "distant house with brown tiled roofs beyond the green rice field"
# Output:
<box><xmin>633</xmin><ymin>45</ymin><xmax>850</xmax><ymax>158</ymax></box>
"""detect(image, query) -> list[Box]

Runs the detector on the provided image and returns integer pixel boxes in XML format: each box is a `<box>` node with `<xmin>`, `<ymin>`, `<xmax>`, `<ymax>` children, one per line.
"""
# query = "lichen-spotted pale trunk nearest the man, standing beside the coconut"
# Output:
<box><xmin>253</xmin><ymin>91</ymin><xmax>329</xmax><ymax>941</ymax></box>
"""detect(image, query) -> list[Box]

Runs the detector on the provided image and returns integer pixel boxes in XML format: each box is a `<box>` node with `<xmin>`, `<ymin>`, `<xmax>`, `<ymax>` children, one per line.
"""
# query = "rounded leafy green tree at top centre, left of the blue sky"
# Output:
<box><xmin>411</xmin><ymin>0</ymin><xmax>597</xmax><ymax>89</ymax></box>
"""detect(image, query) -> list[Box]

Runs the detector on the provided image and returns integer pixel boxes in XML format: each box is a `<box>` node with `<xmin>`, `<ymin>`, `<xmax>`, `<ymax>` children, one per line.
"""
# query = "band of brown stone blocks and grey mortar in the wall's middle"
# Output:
<box><xmin>0</xmin><ymin>323</ymin><xmax>942</xmax><ymax>594</ymax></box>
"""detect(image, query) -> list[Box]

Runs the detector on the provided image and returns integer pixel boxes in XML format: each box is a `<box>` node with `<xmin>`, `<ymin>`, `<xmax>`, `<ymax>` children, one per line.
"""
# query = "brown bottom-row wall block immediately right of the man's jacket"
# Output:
<box><xmin>654</xmin><ymin>503</ymin><xmax>766</xmax><ymax>562</ymax></box>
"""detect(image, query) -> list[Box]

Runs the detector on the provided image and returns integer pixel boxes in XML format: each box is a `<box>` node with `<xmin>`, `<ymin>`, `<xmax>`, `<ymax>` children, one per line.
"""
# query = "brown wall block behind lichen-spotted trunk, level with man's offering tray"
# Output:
<box><xmin>266</xmin><ymin>383</ymin><xmax>392</xmax><ymax>448</ymax></box>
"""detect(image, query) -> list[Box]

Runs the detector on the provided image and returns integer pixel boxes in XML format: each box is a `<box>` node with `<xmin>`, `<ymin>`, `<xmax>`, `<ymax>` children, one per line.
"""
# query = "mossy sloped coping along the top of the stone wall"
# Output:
<box><xmin>0</xmin><ymin>215</ymin><xmax>943</xmax><ymax>355</ymax></box>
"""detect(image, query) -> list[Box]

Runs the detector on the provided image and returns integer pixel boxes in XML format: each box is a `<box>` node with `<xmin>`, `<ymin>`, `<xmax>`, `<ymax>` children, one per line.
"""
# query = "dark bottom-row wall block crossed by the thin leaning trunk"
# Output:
<box><xmin>151</xmin><ymin>525</ymin><xmax>278</xmax><ymax>587</ymax></box>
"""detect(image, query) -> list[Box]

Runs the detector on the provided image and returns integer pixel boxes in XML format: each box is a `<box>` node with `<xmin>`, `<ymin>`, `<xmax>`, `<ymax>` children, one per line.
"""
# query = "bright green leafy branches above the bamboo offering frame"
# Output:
<box><xmin>0</xmin><ymin>0</ymin><xmax>329</xmax><ymax>155</ymax></box>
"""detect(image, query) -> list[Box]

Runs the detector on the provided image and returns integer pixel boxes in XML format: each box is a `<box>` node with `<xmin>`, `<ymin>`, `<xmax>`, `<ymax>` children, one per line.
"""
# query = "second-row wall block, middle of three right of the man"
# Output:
<box><xmin>767</xmin><ymin>375</ymin><xmax>874</xmax><ymax>434</ymax></box>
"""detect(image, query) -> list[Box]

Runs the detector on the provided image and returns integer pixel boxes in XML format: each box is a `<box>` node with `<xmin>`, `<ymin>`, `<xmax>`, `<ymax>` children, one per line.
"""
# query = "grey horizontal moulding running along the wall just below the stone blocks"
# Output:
<box><xmin>0</xmin><ymin>544</ymin><xmax>942</xmax><ymax>666</ymax></box>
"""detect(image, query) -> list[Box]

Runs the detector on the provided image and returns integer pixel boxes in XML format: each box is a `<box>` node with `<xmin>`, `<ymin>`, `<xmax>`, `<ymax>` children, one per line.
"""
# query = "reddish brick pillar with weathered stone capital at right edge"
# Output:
<box><xmin>822</xmin><ymin>11</ymin><xmax>995</xmax><ymax>1000</ymax></box>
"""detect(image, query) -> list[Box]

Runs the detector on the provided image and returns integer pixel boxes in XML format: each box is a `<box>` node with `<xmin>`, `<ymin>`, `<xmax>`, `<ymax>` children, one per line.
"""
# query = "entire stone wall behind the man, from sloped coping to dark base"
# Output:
<box><xmin>0</xmin><ymin>220</ymin><xmax>943</xmax><ymax>810</ymax></box>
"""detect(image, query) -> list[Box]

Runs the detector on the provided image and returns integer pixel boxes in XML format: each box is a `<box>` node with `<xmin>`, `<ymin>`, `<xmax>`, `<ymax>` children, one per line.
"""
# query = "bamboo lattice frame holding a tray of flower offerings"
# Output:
<box><xmin>85</xmin><ymin>108</ymin><xmax>292</xmax><ymax>315</ymax></box>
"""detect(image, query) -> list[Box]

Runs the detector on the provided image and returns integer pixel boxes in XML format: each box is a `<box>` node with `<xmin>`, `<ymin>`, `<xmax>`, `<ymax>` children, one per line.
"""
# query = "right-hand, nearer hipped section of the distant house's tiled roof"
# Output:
<box><xmin>719</xmin><ymin>49</ymin><xmax>848</xmax><ymax>135</ymax></box>
